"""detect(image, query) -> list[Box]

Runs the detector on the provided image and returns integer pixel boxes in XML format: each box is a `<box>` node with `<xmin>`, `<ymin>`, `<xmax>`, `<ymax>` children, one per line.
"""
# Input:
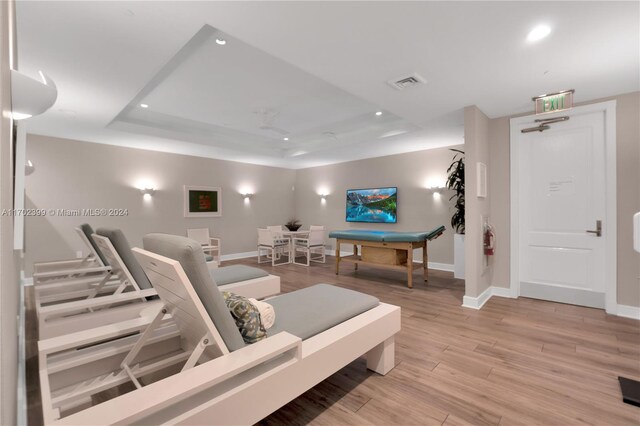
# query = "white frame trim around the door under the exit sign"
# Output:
<box><xmin>510</xmin><ymin>100</ymin><xmax>618</xmax><ymax>315</ymax></box>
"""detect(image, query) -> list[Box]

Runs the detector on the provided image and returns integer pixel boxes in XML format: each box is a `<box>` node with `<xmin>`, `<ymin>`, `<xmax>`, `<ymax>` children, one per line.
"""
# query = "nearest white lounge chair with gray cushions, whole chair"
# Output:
<box><xmin>39</xmin><ymin>235</ymin><xmax>400</xmax><ymax>424</ymax></box>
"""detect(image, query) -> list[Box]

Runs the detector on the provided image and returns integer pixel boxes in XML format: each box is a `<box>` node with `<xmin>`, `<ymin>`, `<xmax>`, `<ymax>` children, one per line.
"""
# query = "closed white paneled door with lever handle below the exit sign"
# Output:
<box><xmin>511</xmin><ymin>103</ymin><xmax>616</xmax><ymax>311</ymax></box>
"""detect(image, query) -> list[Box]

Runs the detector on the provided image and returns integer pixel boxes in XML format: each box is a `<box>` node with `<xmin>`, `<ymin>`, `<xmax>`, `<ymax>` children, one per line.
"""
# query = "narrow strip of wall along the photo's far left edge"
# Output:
<box><xmin>0</xmin><ymin>1</ymin><xmax>20</xmax><ymax>425</ymax></box>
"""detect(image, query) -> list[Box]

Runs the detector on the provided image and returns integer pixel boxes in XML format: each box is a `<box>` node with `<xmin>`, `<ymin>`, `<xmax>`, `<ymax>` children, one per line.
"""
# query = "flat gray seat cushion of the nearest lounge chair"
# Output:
<box><xmin>267</xmin><ymin>284</ymin><xmax>380</xmax><ymax>340</ymax></box>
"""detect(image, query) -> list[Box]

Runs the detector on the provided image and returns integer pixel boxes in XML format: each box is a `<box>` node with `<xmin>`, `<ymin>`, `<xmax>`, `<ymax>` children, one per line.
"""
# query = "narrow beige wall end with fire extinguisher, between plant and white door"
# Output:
<box><xmin>464</xmin><ymin>106</ymin><xmax>494</xmax><ymax>297</ymax></box>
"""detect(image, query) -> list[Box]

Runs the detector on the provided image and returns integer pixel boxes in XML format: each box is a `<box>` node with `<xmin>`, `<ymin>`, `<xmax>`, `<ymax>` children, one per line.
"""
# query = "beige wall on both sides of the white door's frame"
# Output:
<box><xmin>484</xmin><ymin>92</ymin><xmax>640</xmax><ymax>306</ymax></box>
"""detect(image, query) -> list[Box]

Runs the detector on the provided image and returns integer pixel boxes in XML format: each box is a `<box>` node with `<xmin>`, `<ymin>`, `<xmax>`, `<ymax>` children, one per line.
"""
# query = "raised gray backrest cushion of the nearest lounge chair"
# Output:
<box><xmin>142</xmin><ymin>234</ymin><xmax>245</xmax><ymax>351</ymax></box>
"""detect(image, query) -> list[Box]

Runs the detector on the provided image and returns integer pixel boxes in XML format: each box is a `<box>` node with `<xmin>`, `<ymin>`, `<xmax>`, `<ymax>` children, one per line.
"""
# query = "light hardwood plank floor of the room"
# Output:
<box><xmin>27</xmin><ymin>257</ymin><xmax>640</xmax><ymax>426</ymax></box>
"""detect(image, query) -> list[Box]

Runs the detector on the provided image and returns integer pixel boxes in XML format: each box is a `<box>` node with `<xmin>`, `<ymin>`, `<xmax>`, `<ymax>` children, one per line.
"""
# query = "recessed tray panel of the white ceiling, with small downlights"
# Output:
<box><xmin>109</xmin><ymin>25</ymin><xmax>420</xmax><ymax>159</ymax></box>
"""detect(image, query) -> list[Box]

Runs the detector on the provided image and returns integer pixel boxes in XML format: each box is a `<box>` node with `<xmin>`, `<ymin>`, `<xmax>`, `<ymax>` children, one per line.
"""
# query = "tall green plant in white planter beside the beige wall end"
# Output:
<box><xmin>446</xmin><ymin>149</ymin><xmax>465</xmax><ymax>278</ymax></box>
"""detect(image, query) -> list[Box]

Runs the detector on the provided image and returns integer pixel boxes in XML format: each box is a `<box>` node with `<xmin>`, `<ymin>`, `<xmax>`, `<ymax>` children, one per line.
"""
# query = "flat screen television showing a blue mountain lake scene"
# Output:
<box><xmin>347</xmin><ymin>186</ymin><xmax>398</xmax><ymax>223</ymax></box>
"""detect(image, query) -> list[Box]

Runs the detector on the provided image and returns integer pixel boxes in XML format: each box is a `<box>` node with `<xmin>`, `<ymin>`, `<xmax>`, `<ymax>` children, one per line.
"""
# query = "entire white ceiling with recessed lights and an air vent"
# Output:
<box><xmin>17</xmin><ymin>1</ymin><xmax>640</xmax><ymax>168</ymax></box>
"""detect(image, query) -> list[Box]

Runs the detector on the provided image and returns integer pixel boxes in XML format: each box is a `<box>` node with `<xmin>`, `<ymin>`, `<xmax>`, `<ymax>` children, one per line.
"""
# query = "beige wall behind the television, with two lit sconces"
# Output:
<box><xmin>295</xmin><ymin>146</ymin><xmax>462</xmax><ymax>265</ymax></box>
